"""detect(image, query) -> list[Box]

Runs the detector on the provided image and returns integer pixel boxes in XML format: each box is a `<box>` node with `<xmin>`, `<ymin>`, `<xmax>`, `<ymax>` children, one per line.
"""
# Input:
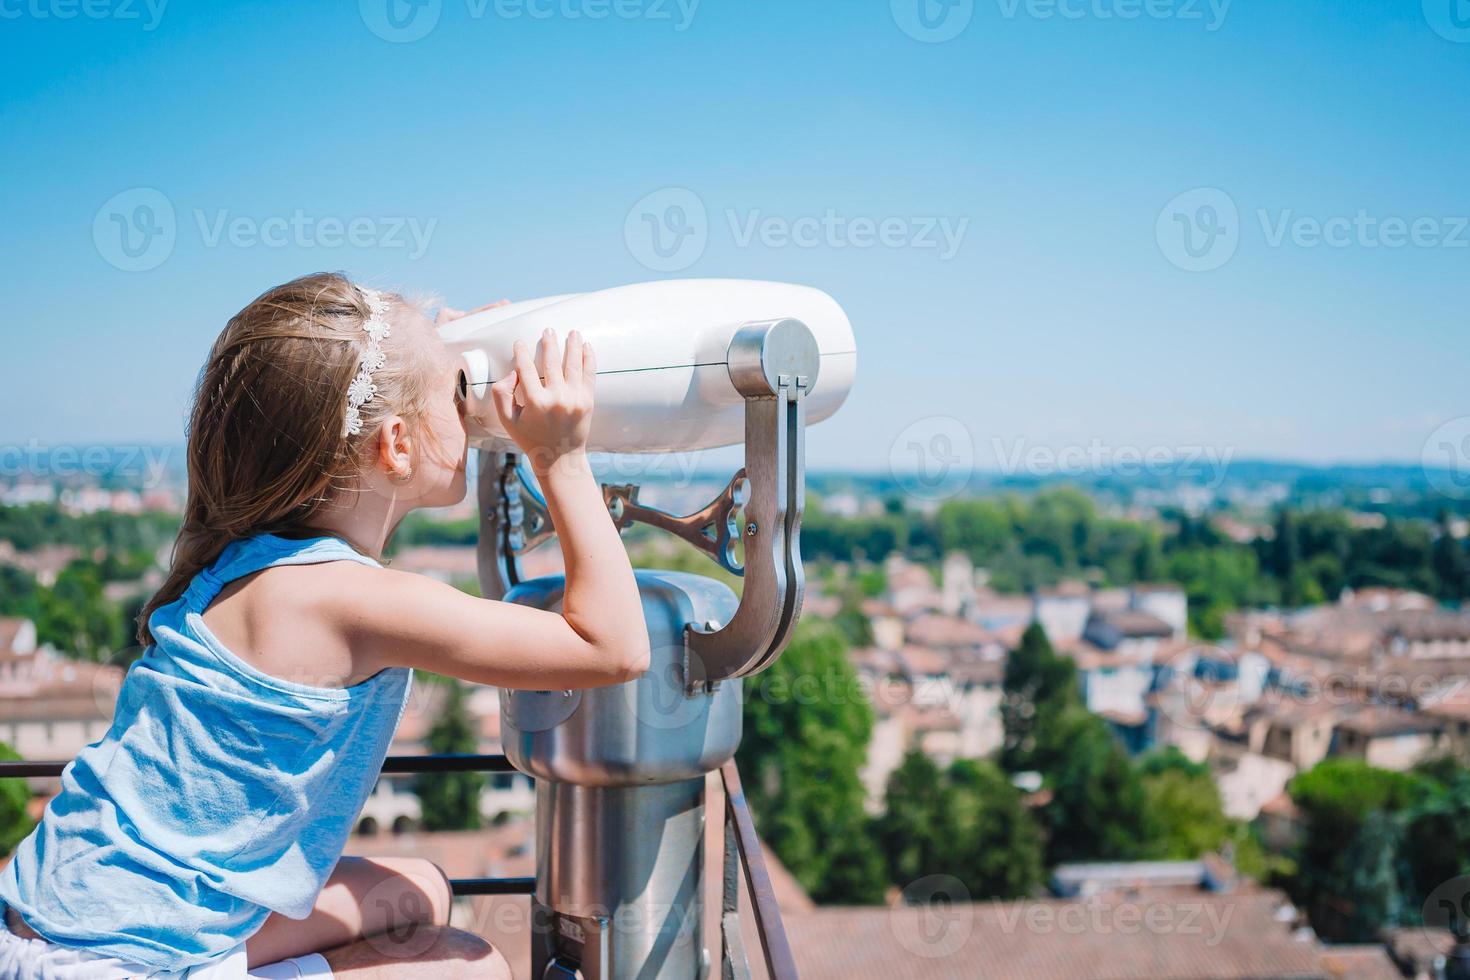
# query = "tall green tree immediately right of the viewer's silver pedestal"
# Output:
<box><xmin>736</xmin><ymin>620</ymin><xmax>886</xmax><ymax>902</ymax></box>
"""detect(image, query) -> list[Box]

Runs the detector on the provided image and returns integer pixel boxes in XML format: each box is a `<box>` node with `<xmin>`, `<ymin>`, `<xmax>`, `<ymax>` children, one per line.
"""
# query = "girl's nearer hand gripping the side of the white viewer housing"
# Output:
<box><xmin>490</xmin><ymin>329</ymin><xmax>597</xmax><ymax>475</ymax></box>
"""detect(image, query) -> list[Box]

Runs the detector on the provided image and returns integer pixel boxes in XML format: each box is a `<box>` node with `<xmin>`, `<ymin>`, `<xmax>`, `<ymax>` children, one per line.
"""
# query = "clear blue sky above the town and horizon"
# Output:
<box><xmin>0</xmin><ymin>0</ymin><xmax>1470</xmax><ymax>469</ymax></box>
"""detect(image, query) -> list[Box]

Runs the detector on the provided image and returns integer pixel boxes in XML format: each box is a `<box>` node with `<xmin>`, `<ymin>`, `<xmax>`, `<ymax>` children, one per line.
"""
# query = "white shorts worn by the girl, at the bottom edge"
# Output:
<box><xmin>0</xmin><ymin>905</ymin><xmax>332</xmax><ymax>980</ymax></box>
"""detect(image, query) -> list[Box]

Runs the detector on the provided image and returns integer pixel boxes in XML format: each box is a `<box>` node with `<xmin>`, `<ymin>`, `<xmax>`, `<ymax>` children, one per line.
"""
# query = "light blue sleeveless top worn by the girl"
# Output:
<box><xmin>0</xmin><ymin>535</ymin><xmax>413</xmax><ymax>973</ymax></box>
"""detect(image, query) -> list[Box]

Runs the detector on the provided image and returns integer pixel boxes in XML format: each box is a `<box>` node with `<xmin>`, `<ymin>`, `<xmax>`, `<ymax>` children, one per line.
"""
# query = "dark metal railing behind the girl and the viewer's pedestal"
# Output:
<box><xmin>0</xmin><ymin>755</ymin><xmax>797</xmax><ymax>980</ymax></box>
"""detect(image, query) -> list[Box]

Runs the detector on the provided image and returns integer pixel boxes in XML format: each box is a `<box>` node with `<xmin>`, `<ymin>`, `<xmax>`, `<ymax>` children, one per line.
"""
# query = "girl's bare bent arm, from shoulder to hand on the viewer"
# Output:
<box><xmin>332</xmin><ymin>331</ymin><xmax>648</xmax><ymax>691</ymax></box>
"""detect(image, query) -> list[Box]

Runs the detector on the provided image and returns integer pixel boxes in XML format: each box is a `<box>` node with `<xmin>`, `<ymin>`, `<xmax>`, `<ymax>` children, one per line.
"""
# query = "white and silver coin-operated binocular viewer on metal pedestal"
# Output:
<box><xmin>442</xmin><ymin>279</ymin><xmax>857</xmax><ymax>980</ymax></box>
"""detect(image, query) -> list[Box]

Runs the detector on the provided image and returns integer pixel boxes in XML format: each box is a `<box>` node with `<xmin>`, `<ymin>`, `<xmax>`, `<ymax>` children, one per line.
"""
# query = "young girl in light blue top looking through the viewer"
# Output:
<box><xmin>0</xmin><ymin>275</ymin><xmax>648</xmax><ymax>980</ymax></box>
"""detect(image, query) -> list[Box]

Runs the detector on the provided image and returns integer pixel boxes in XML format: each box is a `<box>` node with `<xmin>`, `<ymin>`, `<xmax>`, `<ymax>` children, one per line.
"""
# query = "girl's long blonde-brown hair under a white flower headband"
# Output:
<box><xmin>138</xmin><ymin>272</ymin><xmax>428</xmax><ymax>645</ymax></box>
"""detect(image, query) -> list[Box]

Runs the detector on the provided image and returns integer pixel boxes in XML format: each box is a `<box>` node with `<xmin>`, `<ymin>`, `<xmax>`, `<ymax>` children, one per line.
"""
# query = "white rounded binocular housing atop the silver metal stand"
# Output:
<box><xmin>440</xmin><ymin>279</ymin><xmax>857</xmax><ymax>453</ymax></box>
